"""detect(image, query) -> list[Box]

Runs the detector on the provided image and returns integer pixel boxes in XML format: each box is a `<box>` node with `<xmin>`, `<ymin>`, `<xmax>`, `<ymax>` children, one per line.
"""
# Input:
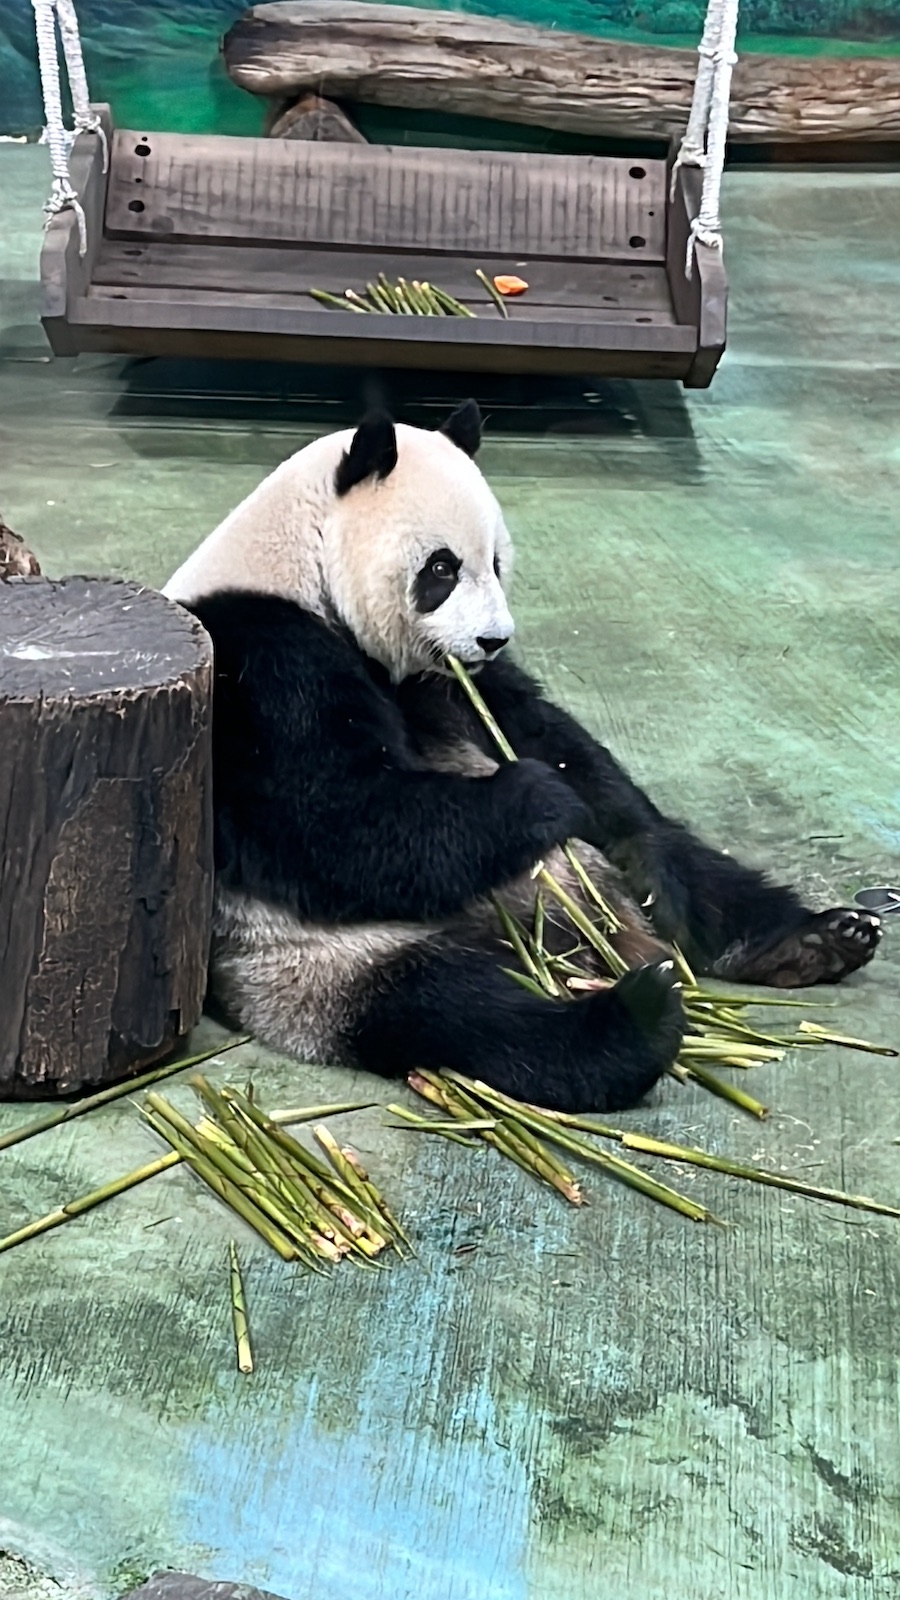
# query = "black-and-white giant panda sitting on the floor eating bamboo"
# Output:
<box><xmin>165</xmin><ymin>402</ymin><xmax>881</xmax><ymax>1110</ymax></box>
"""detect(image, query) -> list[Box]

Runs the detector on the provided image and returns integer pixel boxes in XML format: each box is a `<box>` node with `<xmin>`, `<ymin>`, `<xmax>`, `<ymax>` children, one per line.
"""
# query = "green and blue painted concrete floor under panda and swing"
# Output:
<box><xmin>0</xmin><ymin>147</ymin><xmax>900</xmax><ymax>1600</ymax></box>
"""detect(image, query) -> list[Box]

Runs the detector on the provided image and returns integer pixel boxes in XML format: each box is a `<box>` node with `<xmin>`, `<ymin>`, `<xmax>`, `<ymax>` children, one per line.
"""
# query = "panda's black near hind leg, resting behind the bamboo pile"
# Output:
<box><xmin>351</xmin><ymin>946</ymin><xmax>684</xmax><ymax>1112</ymax></box>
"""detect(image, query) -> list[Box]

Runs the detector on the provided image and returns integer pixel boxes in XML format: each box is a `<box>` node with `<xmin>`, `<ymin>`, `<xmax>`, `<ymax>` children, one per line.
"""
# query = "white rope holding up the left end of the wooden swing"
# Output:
<box><xmin>32</xmin><ymin>0</ymin><xmax>109</xmax><ymax>256</ymax></box>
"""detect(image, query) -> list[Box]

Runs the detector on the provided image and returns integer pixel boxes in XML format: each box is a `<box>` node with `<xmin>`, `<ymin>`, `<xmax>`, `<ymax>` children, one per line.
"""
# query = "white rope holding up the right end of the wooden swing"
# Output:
<box><xmin>673</xmin><ymin>0</ymin><xmax>740</xmax><ymax>277</ymax></box>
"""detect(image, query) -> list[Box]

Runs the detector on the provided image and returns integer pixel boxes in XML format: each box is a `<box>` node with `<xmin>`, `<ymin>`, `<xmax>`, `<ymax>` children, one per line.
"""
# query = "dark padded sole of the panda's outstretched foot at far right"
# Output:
<box><xmin>720</xmin><ymin>906</ymin><xmax>882</xmax><ymax>989</ymax></box>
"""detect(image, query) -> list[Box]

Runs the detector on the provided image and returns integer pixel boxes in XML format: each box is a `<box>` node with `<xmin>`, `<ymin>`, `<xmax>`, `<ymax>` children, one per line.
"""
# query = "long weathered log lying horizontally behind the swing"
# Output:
<box><xmin>223</xmin><ymin>0</ymin><xmax>900</xmax><ymax>142</ymax></box>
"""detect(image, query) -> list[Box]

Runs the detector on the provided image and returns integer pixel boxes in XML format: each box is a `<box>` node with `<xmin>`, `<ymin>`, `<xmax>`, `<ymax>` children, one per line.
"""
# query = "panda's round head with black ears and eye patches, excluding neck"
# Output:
<box><xmin>323</xmin><ymin>400</ymin><xmax>514</xmax><ymax>680</ymax></box>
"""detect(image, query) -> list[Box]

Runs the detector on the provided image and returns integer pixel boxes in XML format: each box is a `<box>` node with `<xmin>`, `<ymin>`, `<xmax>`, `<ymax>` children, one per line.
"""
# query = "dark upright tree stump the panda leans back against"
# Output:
<box><xmin>0</xmin><ymin>578</ymin><xmax>213</xmax><ymax>1098</ymax></box>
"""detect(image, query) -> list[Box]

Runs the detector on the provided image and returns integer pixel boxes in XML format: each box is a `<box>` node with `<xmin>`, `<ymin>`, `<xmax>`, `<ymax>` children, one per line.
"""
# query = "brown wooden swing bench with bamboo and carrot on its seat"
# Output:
<box><xmin>42</xmin><ymin>107</ymin><xmax>727</xmax><ymax>387</ymax></box>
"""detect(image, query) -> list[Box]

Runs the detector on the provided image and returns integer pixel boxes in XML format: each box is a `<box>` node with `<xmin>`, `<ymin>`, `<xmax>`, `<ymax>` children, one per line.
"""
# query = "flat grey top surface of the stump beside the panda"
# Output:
<box><xmin>0</xmin><ymin>578</ymin><xmax>210</xmax><ymax>702</ymax></box>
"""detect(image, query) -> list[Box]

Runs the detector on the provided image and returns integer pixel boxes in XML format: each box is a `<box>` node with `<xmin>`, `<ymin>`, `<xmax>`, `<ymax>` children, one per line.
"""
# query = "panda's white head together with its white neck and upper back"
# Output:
<box><xmin>163</xmin><ymin>400</ymin><xmax>512</xmax><ymax>682</ymax></box>
